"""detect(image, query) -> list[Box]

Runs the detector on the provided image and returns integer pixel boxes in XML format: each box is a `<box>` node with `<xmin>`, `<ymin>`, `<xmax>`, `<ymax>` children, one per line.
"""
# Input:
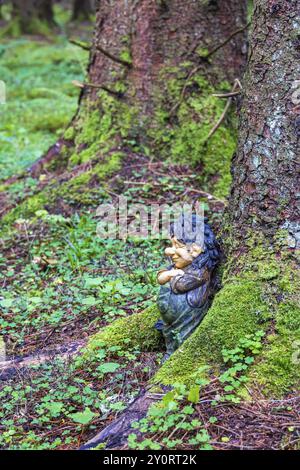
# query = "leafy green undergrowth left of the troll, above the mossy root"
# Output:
<box><xmin>0</xmin><ymin>210</ymin><xmax>162</xmax><ymax>353</ymax></box>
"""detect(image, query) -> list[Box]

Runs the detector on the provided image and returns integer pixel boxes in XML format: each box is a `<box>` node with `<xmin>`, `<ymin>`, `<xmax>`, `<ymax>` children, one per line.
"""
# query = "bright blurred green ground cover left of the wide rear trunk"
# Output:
<box><xmin>0</xmin><ymin>36</ymin><xmax>88</xmax><ymax>180</ymax></box>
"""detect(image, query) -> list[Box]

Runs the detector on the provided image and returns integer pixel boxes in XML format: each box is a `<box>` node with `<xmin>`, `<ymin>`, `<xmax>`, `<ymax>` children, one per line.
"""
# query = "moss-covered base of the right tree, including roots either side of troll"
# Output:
<box><xmin>85</xmin><ymin>252</ymin><xmax>300</xmax><ymax>397</ymax></box>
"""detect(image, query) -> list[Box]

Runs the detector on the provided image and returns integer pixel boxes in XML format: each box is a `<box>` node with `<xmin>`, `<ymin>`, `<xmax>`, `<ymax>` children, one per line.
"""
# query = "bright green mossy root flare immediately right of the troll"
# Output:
<box><xmin>153</xmin><ymin>279</ymin><xmax>270</xmax><ymax>384</ymax></box>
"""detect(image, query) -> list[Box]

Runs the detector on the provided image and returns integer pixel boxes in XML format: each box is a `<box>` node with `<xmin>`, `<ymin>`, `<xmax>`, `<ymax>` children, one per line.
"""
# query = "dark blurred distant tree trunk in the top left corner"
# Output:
<box><xmin>12</xmin><ymin>0</ymin><xmax>54</xmax><ymax>33</ymax></box>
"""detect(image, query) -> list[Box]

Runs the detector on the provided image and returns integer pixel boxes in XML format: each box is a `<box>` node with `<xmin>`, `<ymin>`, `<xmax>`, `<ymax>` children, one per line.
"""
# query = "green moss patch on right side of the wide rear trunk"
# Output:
<box><xmin>148</xmin><ymin>62</ymin><xmax>237</xmax><ymax>197</ymax></box>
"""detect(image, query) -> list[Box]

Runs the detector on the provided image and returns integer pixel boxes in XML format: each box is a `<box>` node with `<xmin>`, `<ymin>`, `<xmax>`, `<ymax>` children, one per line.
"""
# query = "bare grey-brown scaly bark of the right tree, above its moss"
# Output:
<box><xmin>229</xmin><ymin>0</ymin><xmax>300</xmax><ymax>253</ymax></box>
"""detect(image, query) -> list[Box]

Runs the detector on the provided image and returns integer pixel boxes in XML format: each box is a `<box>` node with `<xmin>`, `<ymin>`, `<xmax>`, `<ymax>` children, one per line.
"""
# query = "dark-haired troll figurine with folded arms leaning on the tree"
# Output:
<box><xmin>156</xmin><ymin>214</ymin><xmax>220</xmax><ymax>360</ymax></box>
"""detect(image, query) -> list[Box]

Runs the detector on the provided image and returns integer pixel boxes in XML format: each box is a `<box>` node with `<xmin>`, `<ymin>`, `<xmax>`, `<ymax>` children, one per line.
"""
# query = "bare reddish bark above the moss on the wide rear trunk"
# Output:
<box><xmin>84</xmin><ymin>0</ymin><xmax>246</xmax><ymax>115</ymax></box>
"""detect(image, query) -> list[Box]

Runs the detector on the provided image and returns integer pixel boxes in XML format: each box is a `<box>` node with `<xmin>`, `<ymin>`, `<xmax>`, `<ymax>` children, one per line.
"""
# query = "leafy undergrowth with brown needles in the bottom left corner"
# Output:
<box><xmin>0</xmin><ymin>346</ymin><xmax>159</xmax><ymax>450</ymax></box>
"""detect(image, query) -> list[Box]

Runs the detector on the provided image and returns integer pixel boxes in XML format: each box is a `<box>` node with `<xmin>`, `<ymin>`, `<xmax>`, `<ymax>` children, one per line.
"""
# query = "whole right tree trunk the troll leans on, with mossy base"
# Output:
<box><xmin>156</xmin><ymin>0</ymin><xmax>300</xmax><ymax>396</ymax></box>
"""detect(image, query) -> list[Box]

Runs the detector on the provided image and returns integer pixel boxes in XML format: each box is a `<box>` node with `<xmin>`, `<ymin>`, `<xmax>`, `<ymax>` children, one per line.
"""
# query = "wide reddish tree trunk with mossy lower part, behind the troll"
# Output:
<box><xmin>59</xmin><ymin>0</ymin><xmax>247</xmax><ymax>196</ymax></box>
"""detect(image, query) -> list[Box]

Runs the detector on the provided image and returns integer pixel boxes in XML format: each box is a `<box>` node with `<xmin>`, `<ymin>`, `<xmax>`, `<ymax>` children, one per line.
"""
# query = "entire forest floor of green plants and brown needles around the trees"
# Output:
<box><xmin>0</xmin><ymin>8</ymin><xmax>300</xmax><ymax>449</ymax></box>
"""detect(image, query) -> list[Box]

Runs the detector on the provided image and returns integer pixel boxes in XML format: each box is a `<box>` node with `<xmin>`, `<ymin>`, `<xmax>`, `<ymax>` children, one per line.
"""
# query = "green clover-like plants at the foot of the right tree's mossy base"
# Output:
<box><xmin>128</xmin><ymin>331</ymin><xmax>264</xmax><ymax>450</ymax></box>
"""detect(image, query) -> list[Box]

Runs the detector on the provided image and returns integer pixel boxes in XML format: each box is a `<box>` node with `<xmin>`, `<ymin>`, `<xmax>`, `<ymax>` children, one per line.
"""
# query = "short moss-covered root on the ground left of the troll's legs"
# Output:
<box><xmin>84</xmin><ymin>305</ymin><xmax>162</xmax><ymax>359</ymax></box>
